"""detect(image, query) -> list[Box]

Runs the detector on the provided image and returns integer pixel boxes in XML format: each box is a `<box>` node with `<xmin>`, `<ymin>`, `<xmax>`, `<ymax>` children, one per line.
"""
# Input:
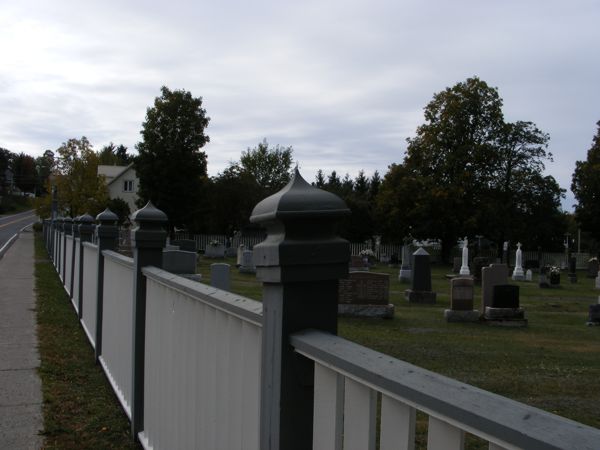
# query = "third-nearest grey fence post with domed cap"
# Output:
<box><xmin>94</xmin><ymin>208</ymin><xmax>119</xmax><ymax>363</ymax></box>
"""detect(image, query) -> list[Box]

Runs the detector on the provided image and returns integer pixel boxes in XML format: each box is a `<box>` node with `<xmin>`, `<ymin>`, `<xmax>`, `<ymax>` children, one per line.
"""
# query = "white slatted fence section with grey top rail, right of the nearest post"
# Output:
<box><xmin>291</xmin><ymin>330</ymin><xmax>600</xmax><ymax>450</ymax></box>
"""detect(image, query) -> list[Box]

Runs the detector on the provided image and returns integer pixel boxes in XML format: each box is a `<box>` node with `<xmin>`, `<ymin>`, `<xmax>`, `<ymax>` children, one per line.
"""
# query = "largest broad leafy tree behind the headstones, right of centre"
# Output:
<box><xmin>377</xmin><ymin>77</ymin><xmax>563</xmax><ymax>260</ymax></box>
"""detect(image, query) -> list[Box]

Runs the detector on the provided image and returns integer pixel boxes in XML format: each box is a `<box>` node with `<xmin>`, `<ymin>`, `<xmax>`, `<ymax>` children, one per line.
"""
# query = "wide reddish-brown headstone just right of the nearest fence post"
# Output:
<box><xmin>338</xmin><ymin>272</ymin><xmax>394</xmax><ymax>318</ymax></box>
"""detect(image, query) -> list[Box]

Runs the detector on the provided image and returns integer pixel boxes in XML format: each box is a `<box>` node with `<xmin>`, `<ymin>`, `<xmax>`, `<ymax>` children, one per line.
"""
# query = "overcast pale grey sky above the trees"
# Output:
<box><xmin>0</xmin><ymin>0</ymin><xmax>600</xmax><ymax>209</ymax></box>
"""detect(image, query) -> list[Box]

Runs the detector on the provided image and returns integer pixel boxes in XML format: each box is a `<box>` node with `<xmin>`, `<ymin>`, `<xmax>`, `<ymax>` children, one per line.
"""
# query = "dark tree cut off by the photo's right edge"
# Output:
<box><xmin>571</xmin><ymin>121</ymin><xmax>600</xmax><ymax>246</ymax></box>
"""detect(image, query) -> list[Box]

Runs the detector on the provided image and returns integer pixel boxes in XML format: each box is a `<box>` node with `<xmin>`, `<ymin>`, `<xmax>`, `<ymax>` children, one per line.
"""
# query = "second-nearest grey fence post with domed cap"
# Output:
<box><xmin>131</xmin><ymin>202</ymin><xmax>168</xmax><ymax>440</ymax></box>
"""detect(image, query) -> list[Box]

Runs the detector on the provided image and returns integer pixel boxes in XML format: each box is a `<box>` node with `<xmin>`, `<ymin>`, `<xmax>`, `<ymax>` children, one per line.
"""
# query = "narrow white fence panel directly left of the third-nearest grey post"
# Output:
<box><xmin>81</xmin><ymin>242</ymin><xmax>98</xmax><ymax>348</ymax></box>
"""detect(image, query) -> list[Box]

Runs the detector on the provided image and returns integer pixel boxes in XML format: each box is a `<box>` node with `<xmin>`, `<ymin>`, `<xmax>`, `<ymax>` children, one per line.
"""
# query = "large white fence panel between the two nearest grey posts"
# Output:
<box><xmin>141</xmin><ymin>268</ymin><xmax>262</xmax><ymax>450</ymax></box>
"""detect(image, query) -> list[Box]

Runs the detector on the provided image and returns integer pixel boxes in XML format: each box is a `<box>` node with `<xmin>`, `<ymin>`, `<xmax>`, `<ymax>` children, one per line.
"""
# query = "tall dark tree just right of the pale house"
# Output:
<box><xmin>134</xmin><ymin>86</ymin><xmax>210</xmax><ymax>229</ymax></box>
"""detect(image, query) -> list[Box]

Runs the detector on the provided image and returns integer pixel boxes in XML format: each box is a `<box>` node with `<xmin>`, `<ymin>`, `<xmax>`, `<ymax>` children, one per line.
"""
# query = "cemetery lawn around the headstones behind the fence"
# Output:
<box><xmin>198</xmin><ymin>257</ymin><xmax>600</xmax><ymax>428</ymax></box>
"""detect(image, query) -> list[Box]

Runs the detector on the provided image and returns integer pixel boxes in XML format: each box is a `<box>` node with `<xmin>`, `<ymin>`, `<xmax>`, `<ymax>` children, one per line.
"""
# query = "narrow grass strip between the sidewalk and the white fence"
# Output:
<box><xmin>35</xmin><ymin>233</ymin><xmax>141</xmax><ymax>449</ymax></box>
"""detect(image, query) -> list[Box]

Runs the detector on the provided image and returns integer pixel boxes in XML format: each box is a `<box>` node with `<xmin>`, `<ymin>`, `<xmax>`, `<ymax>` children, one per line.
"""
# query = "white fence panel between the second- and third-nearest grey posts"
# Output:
<box><xmin>100</xmin><ymin>250</ymin><xmax>133</xmax><ymax>417</ymax></box>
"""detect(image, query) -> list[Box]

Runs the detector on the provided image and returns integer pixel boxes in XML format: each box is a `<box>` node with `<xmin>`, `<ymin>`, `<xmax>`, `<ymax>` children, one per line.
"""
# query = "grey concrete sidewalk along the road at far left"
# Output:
<box><xmin>0</xmin><ymin>228</ymin><xmax>43</xmax><ymax>449</ymax></box>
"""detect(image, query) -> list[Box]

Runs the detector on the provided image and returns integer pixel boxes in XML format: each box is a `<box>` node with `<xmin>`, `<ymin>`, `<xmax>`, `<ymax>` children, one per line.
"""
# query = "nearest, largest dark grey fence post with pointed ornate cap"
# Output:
<box><xmin>250</xmin><ymin>169</ymin><xmax>350</xmax><ymax>450</ymax></box>
